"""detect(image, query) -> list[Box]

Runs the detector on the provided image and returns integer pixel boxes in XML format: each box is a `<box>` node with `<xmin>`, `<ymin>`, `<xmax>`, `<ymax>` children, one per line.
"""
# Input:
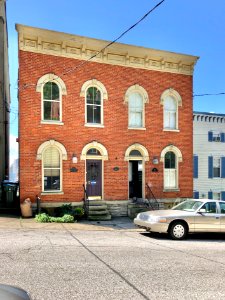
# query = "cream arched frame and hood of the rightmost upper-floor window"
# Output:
<box><xmin>160</xmin><ymin>88</ymin><xmax>182</xmax><ymax>132</ymax></box>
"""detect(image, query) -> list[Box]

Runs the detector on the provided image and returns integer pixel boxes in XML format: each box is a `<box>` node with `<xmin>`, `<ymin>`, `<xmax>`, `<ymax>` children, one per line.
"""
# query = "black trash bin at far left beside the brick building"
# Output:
<box><xmin>2</xmin><ymin>180</ymin><xmax>19</xmax><ymax>208</ymax></box>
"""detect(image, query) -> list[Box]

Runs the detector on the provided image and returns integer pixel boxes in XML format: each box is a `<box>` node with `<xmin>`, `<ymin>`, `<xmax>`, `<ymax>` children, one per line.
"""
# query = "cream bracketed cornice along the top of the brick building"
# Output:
<box><xmin>16</xmin><ymin>24</ymin><xmax>198</xmax><ymax>75</ymax></box>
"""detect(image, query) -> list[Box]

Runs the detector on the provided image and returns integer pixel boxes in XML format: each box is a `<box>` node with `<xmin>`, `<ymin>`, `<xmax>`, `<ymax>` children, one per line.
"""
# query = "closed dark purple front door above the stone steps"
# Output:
<box><xmin>86</xmin><ymin>159</ymin><xmax>102</xmax><ymax>198</ymax></box>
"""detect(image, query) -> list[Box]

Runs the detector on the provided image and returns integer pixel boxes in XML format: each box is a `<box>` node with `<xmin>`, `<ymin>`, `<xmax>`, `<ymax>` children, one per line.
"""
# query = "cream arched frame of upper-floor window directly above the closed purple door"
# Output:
<box><xmin>80</xmin><ymin>79</ymin><xmax>108</xmax><ymax>127</ymax></box>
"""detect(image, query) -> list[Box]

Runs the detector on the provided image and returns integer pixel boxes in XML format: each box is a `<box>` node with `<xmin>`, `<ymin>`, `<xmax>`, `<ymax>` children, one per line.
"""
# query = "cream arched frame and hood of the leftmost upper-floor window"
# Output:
<box><xmin>36</xmin><ymin>73</ymin><xmax>67</xmax><ymax>125</ymax></box>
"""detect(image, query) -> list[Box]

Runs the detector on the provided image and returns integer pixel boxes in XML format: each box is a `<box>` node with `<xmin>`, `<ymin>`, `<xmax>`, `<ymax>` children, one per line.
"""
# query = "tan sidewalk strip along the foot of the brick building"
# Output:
<box><xmin>0</xmin><ymin>215</ymin><xmax>141</xmax><ymax>231</ymax></box>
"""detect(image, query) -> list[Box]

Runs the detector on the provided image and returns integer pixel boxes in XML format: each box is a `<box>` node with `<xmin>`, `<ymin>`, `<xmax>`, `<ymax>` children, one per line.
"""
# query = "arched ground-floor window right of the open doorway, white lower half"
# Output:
<box><xmin>164</xmin><ymin>151</ymin><xmax>177</xmax><ymax>189</ymax></box>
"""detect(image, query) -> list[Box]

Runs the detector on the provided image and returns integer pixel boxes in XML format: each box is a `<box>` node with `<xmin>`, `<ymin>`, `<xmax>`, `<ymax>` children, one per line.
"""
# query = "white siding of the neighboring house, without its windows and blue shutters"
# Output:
<box><xmin>193</xmin><ymin>113</ymin><xmax>225</xmax><ymax>198</ymax></box>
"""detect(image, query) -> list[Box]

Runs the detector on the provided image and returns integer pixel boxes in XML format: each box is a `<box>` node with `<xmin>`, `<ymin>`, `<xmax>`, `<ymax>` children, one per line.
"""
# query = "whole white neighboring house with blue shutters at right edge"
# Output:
<box><xmin>193</xmin><ymin>112</ymin><xmax>225</xmax><ymax>200</ymax></box>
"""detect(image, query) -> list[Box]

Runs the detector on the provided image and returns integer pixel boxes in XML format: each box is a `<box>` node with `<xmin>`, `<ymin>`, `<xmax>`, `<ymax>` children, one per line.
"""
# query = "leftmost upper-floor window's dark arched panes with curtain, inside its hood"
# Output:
<box><xmin>42</xmin><ymin>82</ymin><xmax>61</xmax><ymax>121</ymax></box>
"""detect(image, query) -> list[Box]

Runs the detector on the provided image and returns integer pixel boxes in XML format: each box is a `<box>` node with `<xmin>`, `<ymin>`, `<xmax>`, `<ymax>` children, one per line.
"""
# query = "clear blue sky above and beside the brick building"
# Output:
<box><xmin>7</xmin><ymin>0</ymin><xmax>225</xmax><ymax>137</ymax></box>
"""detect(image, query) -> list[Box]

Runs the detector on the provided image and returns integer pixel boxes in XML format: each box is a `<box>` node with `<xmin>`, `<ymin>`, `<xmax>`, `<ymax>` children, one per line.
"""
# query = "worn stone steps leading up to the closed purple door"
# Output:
<box><xmin>87</xmin><ymin>200</ymin><xmax>112</xmax><ymax>221</ymax></box>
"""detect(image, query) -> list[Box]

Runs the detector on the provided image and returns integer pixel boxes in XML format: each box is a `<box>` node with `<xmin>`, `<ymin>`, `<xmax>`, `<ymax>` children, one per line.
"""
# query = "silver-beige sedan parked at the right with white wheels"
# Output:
<box><xmin>134</xmin><ymin>199</ymin><xmax>225</xmax><ymax>240</ymax></box>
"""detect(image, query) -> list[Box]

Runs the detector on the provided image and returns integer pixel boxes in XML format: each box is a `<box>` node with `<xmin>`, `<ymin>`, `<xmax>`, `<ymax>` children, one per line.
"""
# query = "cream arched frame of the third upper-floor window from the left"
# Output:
<box><xmin>124</xmin><ymin>84</ymin><xmax>149</xmax><ymax>130</ymax></box>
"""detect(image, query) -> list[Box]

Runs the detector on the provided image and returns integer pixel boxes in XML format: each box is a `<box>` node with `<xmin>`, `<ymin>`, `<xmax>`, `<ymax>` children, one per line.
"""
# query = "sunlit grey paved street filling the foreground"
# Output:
<box><xmin>0</xmin><ymin>220</ymin><xmax>225</xmax><ymax>300</ymax></box>
